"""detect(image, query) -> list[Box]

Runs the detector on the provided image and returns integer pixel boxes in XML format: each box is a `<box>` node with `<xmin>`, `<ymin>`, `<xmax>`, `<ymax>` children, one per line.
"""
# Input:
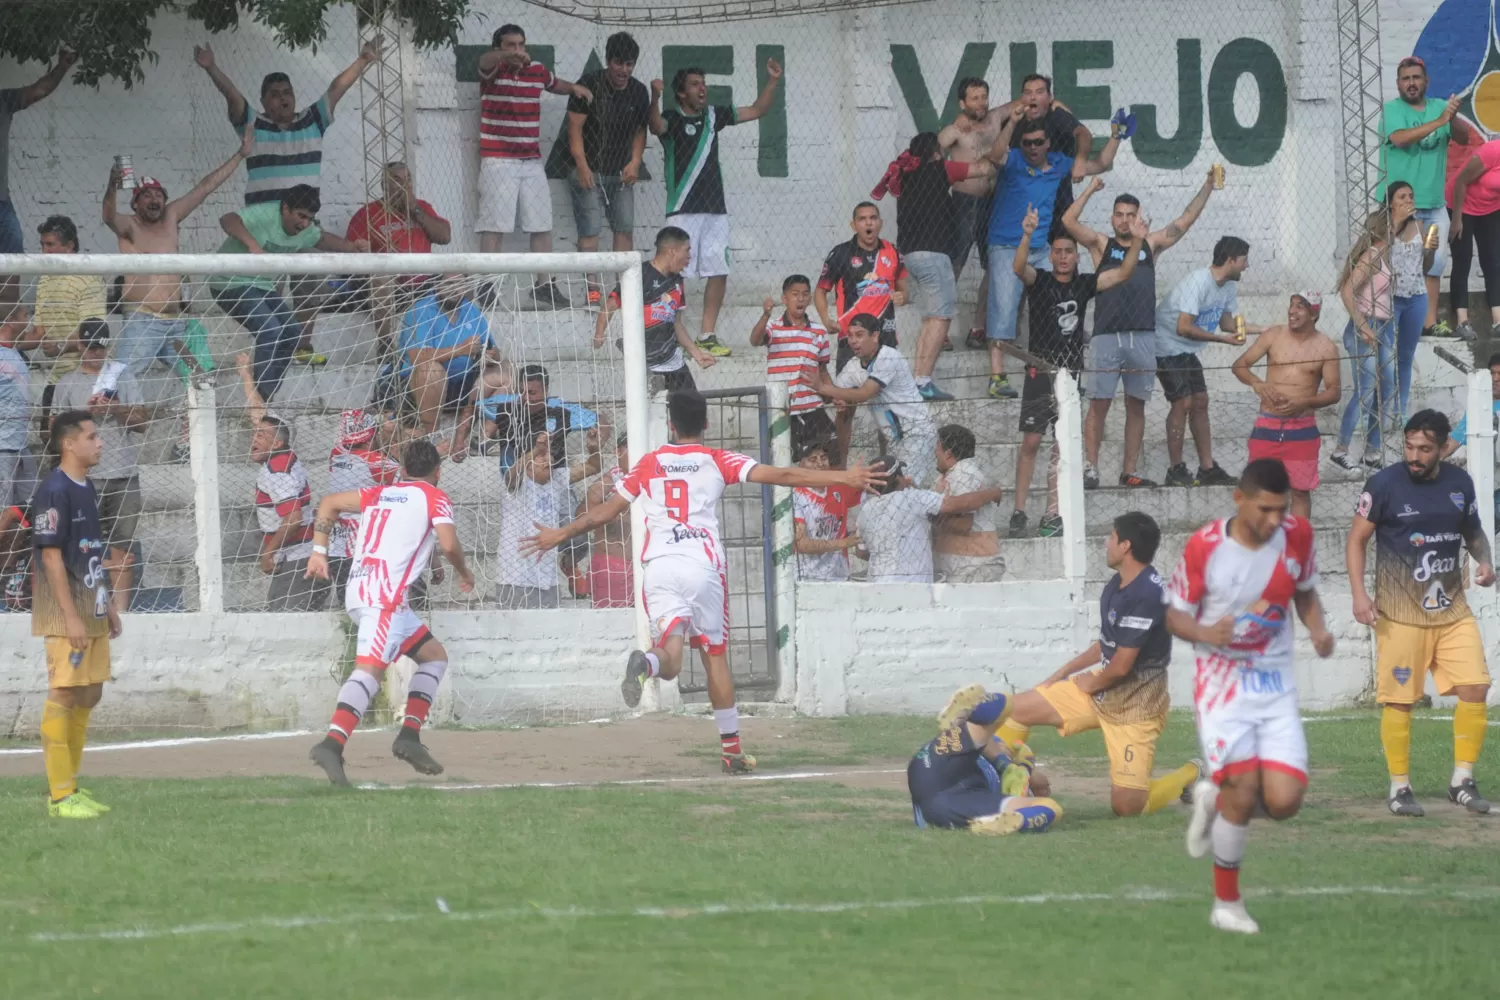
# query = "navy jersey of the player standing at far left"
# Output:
<box><xmin>32</xmin><ymin>469</ymin><xmax>110</xmax><ymax>636</ymax></box>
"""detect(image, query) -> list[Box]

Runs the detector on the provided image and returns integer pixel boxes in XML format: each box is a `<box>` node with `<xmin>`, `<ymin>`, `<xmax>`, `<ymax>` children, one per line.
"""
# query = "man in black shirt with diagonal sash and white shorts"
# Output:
<box><xmin>648</xmin><ymin>58</ymin><xmax>782</xmax><ymax>357</ymax></box>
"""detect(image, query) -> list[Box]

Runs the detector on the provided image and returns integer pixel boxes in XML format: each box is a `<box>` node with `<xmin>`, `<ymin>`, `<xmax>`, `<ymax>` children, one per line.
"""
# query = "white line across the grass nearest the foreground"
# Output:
<box><xmin>26</xmin><ymin>886</ymin><xmax>1500</xmax><ymax>945</ymax></box>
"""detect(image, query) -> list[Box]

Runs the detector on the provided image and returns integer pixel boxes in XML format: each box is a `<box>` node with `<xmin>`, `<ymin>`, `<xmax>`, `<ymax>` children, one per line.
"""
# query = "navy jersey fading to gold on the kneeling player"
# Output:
<box><xmin>1094</xmin><ymin>567</ymin><xmax>1172</xmax><ymax>723</ymax></box>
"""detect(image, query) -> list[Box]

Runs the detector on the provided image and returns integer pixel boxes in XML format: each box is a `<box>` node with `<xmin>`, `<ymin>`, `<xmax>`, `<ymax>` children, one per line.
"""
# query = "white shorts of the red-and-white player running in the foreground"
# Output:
<box><xmin>1193</xmin><ymin>668</ymin><xmax>1308</xmax><ymax>784</ymax></box>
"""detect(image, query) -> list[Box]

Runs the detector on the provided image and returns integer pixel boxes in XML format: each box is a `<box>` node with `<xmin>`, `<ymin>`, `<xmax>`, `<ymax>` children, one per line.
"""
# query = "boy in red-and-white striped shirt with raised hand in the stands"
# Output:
<box><xmin>750</xmin><ymin>274</ymin><xmax>834</xmax><ymax>451</ymax></box>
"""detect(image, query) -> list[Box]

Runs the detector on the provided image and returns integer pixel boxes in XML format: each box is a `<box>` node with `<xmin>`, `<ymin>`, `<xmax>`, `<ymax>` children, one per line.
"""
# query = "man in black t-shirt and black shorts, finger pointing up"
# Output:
<box><xmin>1010</xmin><ymin>207</ymin><xmax>1146</xmax><ymax>538</ymax></box>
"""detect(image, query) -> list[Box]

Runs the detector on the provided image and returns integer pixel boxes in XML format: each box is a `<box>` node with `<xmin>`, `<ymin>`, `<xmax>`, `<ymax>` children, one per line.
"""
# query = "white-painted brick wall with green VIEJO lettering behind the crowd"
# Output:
<box><xmin>0</xmin><ymin>0</ymin><xmax>1446</xmax><ymax>303</ymax></box>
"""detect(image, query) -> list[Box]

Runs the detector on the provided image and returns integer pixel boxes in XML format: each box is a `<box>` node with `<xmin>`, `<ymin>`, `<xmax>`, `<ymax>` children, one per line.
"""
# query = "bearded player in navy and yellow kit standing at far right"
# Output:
<box><xmin>1346</xmin><ymin>409</ymin><xmax>1496</xmax><ymax>816</ymax></box>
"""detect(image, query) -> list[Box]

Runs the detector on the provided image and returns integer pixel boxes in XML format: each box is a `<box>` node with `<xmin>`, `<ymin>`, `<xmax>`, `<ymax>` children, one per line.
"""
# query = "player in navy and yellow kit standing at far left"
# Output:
<box><xmin>32</xmin><ymin>409</ymin><xmax>120</xmax><ymax>820</ymax></box>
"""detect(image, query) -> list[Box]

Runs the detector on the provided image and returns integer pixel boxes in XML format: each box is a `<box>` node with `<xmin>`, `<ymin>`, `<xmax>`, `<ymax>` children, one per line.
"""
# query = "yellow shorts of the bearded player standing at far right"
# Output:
<box><xmin>1376</xmin><ymin>615</ymin><xmax>1490</xmax><ymax>705</ymax></box>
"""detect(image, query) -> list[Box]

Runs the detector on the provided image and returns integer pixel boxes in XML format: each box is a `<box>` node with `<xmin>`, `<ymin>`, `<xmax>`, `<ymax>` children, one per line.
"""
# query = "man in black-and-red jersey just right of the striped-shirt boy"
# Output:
<box><xmin>813</xmin><ymin>201</ymin><xmax>906</xmax><ymax>372</ymax></box>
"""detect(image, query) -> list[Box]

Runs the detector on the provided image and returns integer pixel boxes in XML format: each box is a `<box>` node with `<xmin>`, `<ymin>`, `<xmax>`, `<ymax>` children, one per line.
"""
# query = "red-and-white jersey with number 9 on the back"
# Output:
<box><xmin>615</xmin><ymin>444</ymin><xmax>756</xmax><ymax>570</ymax></box>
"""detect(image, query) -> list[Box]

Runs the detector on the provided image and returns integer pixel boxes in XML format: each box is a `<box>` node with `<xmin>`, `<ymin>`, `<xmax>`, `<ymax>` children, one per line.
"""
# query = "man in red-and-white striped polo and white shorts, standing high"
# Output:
<box><xmin>474</xmin><ymin>24</ymin><xmax>594</xmax><ymax>309</ymax></box>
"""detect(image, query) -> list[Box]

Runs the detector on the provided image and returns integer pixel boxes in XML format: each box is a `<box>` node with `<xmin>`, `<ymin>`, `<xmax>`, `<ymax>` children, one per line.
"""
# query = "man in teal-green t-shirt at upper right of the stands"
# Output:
<box><xmin>1379</xmin><ymin>55</ymin><xmax>1469</xmax><ymax>337</ymax></box>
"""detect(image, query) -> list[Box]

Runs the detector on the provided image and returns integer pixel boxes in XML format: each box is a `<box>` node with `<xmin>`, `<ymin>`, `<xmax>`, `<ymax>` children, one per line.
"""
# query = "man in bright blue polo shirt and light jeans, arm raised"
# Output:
<box><xmin>986</xmin><ymin>116</ymin><xmax>1106</xmax><ymax>399</ymax></box>
